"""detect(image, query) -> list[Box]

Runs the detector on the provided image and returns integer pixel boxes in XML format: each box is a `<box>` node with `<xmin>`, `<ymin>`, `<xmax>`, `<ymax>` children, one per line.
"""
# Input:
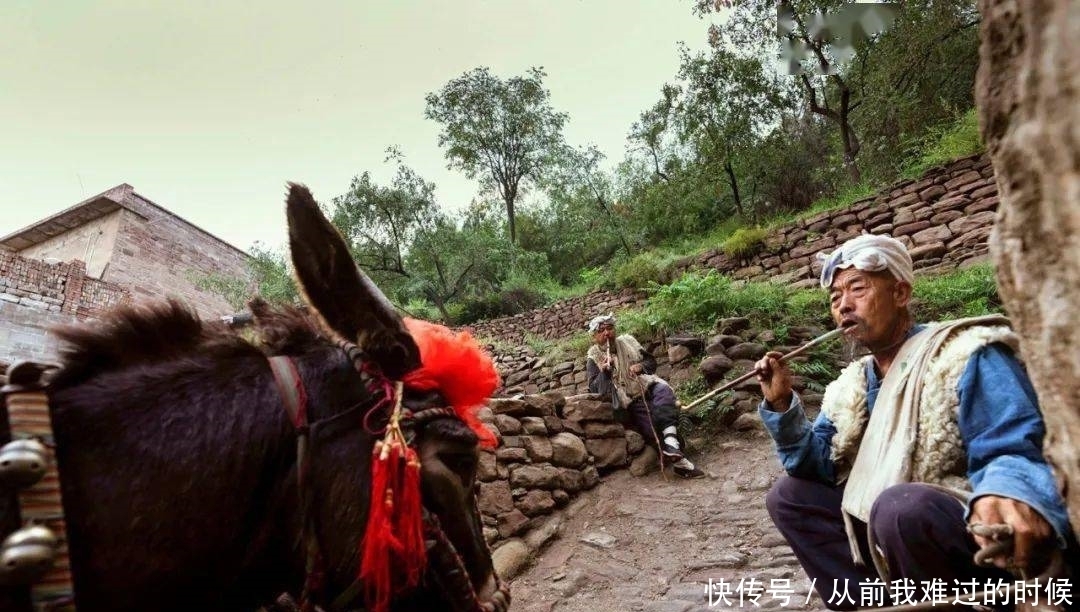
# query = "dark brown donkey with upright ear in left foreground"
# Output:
<box><xmin>0</xmin><ymin>183</ymin><xmax>509</xmax><ymax>612</ymax></box>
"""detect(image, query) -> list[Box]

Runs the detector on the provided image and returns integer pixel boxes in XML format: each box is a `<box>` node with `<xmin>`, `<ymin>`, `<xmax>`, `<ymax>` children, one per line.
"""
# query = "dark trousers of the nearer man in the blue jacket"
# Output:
<box><xmin>766</xmin><ymin>476</ymin><xmax>1016</xmax><ymax>610</ymax></box>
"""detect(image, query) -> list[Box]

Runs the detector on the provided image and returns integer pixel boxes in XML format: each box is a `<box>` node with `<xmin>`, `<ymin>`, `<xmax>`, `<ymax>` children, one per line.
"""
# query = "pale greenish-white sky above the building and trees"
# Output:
<box><xmin>0</xmin><ymin>0</ymin><xmax>707</xmax><ymax>249</ymax></box>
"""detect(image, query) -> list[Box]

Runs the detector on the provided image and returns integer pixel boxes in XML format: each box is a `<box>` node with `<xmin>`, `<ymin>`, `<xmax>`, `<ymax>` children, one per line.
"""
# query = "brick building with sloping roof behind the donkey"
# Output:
<box><xmin>0</xmin><ymin>183</ymin><xmax>248</xmax><ymax>363</ymax></box>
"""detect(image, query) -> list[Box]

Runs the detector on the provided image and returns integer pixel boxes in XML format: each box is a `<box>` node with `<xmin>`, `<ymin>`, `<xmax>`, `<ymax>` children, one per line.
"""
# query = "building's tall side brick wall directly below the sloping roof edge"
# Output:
<box><xmin>103</xmin><ymin>192</ymin><xmax>247</xmax><ymax>318</ymax></box>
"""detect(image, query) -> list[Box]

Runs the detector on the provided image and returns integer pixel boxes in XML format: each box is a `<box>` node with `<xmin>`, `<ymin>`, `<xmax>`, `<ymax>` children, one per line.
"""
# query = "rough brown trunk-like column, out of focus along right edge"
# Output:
<box><xmin>975</xmin><ymin>0</ymin><xmax>1080</xmax><ymax>539</ymax></box>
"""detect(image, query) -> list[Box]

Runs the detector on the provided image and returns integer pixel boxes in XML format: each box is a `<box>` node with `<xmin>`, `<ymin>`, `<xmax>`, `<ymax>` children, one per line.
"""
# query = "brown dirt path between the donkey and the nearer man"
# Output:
<box><xmin>512</xmin><ymin>431</ymin><xmax>824</xmax><ymax>612</ymax></box>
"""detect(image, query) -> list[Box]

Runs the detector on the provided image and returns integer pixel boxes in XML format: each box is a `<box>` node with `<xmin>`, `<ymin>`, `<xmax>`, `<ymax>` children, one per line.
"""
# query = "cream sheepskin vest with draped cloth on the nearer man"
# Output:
<box><xmin>822</xmin><ymin>315</ymin><xmax>1018</xmax><ymax>581</ymax></box>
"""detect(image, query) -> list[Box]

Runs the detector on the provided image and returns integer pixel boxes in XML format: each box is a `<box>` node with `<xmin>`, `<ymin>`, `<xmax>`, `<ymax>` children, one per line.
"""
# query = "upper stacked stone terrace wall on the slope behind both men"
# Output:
<box><xmin>471</xmin><ymin>154</ymin><xmax>998</xmax><ymax>344</ymax></box>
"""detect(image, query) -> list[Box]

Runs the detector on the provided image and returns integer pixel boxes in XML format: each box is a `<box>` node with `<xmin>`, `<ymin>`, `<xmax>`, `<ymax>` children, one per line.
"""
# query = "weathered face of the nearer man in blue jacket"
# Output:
<box><xmin>828</xmin><ymin>268</ymin><xmax>912</xmax><ymax>351</ymax></box>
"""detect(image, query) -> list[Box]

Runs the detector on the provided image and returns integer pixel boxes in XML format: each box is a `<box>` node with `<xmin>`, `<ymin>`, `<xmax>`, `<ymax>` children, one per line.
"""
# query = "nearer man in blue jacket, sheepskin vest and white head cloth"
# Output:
<box><xmin>756</xmin><ymin>235</ymin><xmax>1071</xmax><ymax>610</ymax></box>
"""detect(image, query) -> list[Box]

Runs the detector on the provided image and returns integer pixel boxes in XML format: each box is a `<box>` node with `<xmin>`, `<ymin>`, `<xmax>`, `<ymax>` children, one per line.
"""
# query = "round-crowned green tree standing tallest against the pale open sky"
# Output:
<box><xmin>424</xmin><ymin>67</ymin><xmax>567</xmax><ymax>243</ymax></box>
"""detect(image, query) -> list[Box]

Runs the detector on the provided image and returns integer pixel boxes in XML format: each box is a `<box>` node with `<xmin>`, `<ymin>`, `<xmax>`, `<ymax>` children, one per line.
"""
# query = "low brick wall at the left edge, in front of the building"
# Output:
<box><xmin>0</xmin><ymin>250</ymin><xmax>127</xmax><ymax>364</ymax></box>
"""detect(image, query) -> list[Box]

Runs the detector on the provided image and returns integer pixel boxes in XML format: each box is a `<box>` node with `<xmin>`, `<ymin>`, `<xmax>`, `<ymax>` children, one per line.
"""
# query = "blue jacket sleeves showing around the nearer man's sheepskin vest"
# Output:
<box><xmin>758</xmin><ymin>344</ymin><xmax>1070</xmax><ymax>545</ymax></box>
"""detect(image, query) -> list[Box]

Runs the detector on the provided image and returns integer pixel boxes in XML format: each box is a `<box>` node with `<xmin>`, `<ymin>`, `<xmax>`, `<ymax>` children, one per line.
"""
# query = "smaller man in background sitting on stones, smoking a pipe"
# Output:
<box><xmin>585</xmin><ymin>314</ymin><xmax>705</xmax><ymax>478</ymax></box>
